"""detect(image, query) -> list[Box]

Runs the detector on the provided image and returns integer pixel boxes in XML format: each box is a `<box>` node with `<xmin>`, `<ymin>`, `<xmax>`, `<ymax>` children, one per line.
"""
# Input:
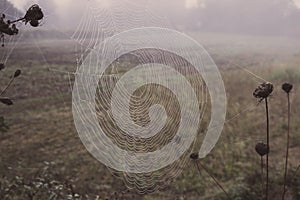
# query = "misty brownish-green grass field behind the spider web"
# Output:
<box><xmin>0</xmin><ymin>33</ymin><xmax>300</xmax><ymax>200</ymax></box>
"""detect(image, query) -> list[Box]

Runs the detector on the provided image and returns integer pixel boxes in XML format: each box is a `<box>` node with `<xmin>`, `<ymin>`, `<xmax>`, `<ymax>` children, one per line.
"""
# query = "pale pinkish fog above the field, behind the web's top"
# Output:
<box><xmin>5</xmin><ymin>0</ymin><xmax>300</xmax><ymax>36</ymax></box>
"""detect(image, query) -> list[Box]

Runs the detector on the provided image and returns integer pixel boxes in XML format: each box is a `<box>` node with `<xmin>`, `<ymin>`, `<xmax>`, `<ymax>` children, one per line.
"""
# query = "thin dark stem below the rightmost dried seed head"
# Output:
<box><xmin>282</xmin><ymin>93</ymin><xmax>291</xmax><ymax>200</ymax></box>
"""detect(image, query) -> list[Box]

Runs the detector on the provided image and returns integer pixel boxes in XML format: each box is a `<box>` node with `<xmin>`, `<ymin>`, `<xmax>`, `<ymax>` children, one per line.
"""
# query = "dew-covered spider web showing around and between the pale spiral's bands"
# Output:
<box><xmin>65</xmin><ymin>0</ymin><xmax>274</xmax><ymax>194</ymax></box>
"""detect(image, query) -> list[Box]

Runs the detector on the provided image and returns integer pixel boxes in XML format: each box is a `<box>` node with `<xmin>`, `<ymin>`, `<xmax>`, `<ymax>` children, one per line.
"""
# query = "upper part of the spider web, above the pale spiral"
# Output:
<box><xmin>71</xmin><ymin>0</ymin><xmax>169</xmax><ymax>50</ymax></box>
